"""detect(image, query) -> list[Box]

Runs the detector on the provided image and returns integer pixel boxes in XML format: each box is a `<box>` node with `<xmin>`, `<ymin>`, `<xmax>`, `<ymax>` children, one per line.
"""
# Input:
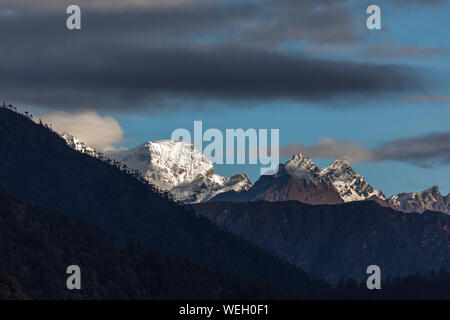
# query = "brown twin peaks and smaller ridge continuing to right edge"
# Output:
<box><xmin>211</xmin><ymin>154</ymin><xmax>450</xmax><ymax>214</ymax></box>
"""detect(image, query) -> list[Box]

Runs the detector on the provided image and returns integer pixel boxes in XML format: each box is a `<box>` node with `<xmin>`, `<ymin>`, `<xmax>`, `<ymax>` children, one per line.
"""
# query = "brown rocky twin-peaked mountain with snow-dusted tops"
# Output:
<box><xmin>212</xmin><ymin>154</ymin><xmax>386</xmax><ymax>204</ymax></box>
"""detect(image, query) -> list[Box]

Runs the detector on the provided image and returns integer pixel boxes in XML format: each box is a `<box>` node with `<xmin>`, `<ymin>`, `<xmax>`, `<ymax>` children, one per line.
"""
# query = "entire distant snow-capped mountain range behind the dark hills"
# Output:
<box><xmin>61</xmin><ymin>133</ymin><xmax>450</xmax><ymax>214</ymax></box>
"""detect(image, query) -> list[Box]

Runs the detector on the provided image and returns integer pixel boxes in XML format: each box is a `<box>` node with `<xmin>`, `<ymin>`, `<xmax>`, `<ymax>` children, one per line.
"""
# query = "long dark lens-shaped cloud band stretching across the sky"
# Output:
<box><xmin>0</xmin><ymin>45</ymin><xmax>420</xmax><ymax>108</ymax></box>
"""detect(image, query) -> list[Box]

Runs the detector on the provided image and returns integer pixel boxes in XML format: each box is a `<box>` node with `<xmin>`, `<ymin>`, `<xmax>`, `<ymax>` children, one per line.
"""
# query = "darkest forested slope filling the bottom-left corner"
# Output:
<box><xmin>0</xmin><ymin>190</ymin><xmax>288</xmax><ymax>299</ymax></box>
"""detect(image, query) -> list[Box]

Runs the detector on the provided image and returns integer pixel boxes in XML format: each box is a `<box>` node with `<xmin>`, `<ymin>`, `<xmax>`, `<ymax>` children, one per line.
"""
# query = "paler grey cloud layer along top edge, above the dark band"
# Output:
<box><xmin>0</xmin><ymin>0</ymin><xmax>359</xmax><ymax>45</ymax></box>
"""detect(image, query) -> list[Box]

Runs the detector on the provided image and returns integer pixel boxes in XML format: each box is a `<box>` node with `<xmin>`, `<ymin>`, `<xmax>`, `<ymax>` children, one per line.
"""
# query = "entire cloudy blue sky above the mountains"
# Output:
<box><xmin>0</xmin><ymin>0</ymin><xmax>450</xmax><ymax>196</ymax></box>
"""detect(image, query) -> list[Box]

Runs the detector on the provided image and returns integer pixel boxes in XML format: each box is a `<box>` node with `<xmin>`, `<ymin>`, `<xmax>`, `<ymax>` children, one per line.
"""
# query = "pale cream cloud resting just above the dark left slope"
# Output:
<box><xmin>41</xmin><ymin>111</ymin><xmax>123</xmax><ymax>151</ymax></box>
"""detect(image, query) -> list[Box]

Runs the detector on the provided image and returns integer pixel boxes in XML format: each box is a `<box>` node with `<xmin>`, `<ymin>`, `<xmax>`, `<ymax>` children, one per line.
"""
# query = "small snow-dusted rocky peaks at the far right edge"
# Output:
<box><xmin>388</xmin><ymin>186</ymin><xmax>450</xmax><ymax>214</ymax></box>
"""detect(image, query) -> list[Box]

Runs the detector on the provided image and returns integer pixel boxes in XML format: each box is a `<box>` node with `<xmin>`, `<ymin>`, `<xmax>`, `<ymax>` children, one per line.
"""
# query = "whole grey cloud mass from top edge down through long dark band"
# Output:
<box><xmin>0</xmin><ymin>0</ymin><xmax>436</xmax><ymax>109</ymax></box>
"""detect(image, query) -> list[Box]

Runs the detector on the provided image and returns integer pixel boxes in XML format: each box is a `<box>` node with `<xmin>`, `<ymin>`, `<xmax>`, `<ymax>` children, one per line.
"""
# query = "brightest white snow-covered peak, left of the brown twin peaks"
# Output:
<box><xmin>110</xmin><ymin>140</ymin><xmax>251</xmax><ymax>203</ymax></box>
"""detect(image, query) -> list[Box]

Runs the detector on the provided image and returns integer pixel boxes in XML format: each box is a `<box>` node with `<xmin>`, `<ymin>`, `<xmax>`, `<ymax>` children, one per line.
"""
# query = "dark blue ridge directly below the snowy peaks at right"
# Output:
<box><xmin>195</xmin><ymin>201</ymin><xmax>450</xmax><ymax>282</ymax></box>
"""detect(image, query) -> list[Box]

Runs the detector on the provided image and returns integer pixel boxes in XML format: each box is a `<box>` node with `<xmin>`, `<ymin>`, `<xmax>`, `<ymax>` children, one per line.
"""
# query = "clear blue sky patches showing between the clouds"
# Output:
<box><xmin>100</xmin><ymin>3</ymin><xmax>450</xmax><ymax>195</ymax></box>
